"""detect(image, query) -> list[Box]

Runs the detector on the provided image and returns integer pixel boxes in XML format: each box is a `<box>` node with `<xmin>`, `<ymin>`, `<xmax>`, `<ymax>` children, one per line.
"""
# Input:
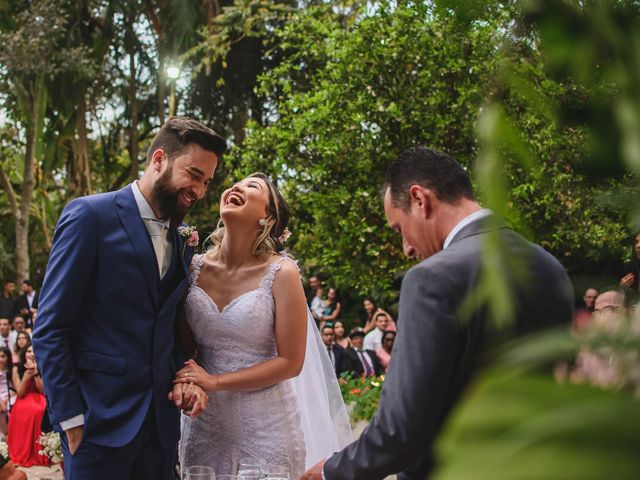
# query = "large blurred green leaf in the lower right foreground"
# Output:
<box><xmin>434</xmin><ymin>369</ymin><xmax>640</xmax><ymax>480</ymax></box>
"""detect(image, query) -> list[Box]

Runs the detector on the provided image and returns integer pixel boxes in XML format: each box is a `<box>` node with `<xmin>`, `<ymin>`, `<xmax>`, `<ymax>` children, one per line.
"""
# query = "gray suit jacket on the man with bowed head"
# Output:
<box><xmin>324</xmin><ymin>216</ymin><xmax>573</xmax><ymax>480</ymax></box>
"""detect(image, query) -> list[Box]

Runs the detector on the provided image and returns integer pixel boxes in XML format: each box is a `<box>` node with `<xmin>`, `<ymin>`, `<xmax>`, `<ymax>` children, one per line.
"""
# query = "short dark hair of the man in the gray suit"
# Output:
<box><xmin>382</xmin><ymin>147</ymin><xmax>475</xmax><ymax>211</ymax></box>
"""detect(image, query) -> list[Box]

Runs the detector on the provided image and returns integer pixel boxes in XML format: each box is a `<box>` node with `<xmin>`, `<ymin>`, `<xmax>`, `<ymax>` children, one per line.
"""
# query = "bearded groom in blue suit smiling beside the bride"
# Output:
<box><xmin>33</xmin><ymin>117</ymin><xmax>226</xmax><ymax>480</ymax></box>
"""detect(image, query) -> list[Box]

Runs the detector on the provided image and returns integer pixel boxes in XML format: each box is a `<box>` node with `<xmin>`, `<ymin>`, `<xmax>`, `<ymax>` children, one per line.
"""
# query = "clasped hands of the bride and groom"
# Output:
<box><xmin>169</xmin><ymin>360</ymin><xmax>210</xmax><ymax>417</ymax></box>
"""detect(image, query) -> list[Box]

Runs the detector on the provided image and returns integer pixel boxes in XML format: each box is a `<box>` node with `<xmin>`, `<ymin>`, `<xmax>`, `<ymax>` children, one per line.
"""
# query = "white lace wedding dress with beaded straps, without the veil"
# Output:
<box><xmin>179</xmin><ymin>256</ymin><xmax>314</xmax><ymax>478</ymax></box>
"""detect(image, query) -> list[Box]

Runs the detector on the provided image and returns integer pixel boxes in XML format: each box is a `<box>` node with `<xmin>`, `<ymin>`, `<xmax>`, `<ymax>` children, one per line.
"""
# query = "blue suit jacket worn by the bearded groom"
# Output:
<box><xmin>33</xmin><ymin>186</ymin><xmax>191</xmax><ymax>448</ymax></box>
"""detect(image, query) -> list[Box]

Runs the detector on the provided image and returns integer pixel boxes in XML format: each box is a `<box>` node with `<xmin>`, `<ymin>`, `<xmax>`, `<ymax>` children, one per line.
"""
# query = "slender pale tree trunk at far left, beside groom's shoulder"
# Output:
<box><xmin>15</xmin><ymin>80</ymin><xmax>42</xmax><ymax>283</ymax></box>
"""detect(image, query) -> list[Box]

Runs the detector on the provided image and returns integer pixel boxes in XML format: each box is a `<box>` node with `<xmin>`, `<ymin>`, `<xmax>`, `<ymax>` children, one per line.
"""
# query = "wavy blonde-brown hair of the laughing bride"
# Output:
<box><xmin>207</xmin><ymin>172</ymin><xmax>290</xmax><ymax>257</ymax></box>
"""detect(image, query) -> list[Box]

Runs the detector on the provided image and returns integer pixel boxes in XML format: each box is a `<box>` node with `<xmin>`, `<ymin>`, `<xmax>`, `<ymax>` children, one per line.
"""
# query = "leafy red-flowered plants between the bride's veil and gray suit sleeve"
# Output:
<box><xmin>340</xmin><ymin>375</ymin><xmax>384</xmax><ymax>424</ymax></box>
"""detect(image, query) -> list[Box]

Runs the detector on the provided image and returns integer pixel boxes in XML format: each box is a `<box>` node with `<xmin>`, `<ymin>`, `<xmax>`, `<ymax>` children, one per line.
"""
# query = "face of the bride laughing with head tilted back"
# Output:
<box><xmin>220</xmin><ymin>177</ymin><xmax>269</xmax><ymax>228</ymax></box>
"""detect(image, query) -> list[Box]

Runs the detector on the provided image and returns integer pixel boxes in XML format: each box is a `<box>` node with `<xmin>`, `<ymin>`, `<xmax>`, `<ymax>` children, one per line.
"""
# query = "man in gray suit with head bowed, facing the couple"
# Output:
<box><xmin>302</xmin><ymin>147</ymin><xmax>573</xmax><ymax>480</ymax></box>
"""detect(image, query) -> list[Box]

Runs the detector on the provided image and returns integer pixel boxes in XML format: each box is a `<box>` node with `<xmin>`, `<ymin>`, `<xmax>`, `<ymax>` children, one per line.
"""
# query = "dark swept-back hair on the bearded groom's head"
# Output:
<box><xmin>147</xmin><ymin>117</ymin><xmax>227</xmax><ymax>165</ymax></box>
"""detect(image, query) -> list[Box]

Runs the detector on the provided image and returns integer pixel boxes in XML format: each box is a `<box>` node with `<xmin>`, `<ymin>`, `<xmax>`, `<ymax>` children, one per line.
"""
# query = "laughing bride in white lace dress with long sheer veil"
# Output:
<box><xmin>175</xmin><ymin>173</ymin><xmax>351</xmax><ymax>479</ymax></box>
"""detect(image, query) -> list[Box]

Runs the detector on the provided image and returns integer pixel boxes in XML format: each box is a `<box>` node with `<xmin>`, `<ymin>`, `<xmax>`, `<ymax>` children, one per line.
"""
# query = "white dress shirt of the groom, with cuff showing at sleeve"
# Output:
<box><xmin>60</xmin><ymin>180</ymin><xmax>173</xmax><ymax>430</ymax></box>
